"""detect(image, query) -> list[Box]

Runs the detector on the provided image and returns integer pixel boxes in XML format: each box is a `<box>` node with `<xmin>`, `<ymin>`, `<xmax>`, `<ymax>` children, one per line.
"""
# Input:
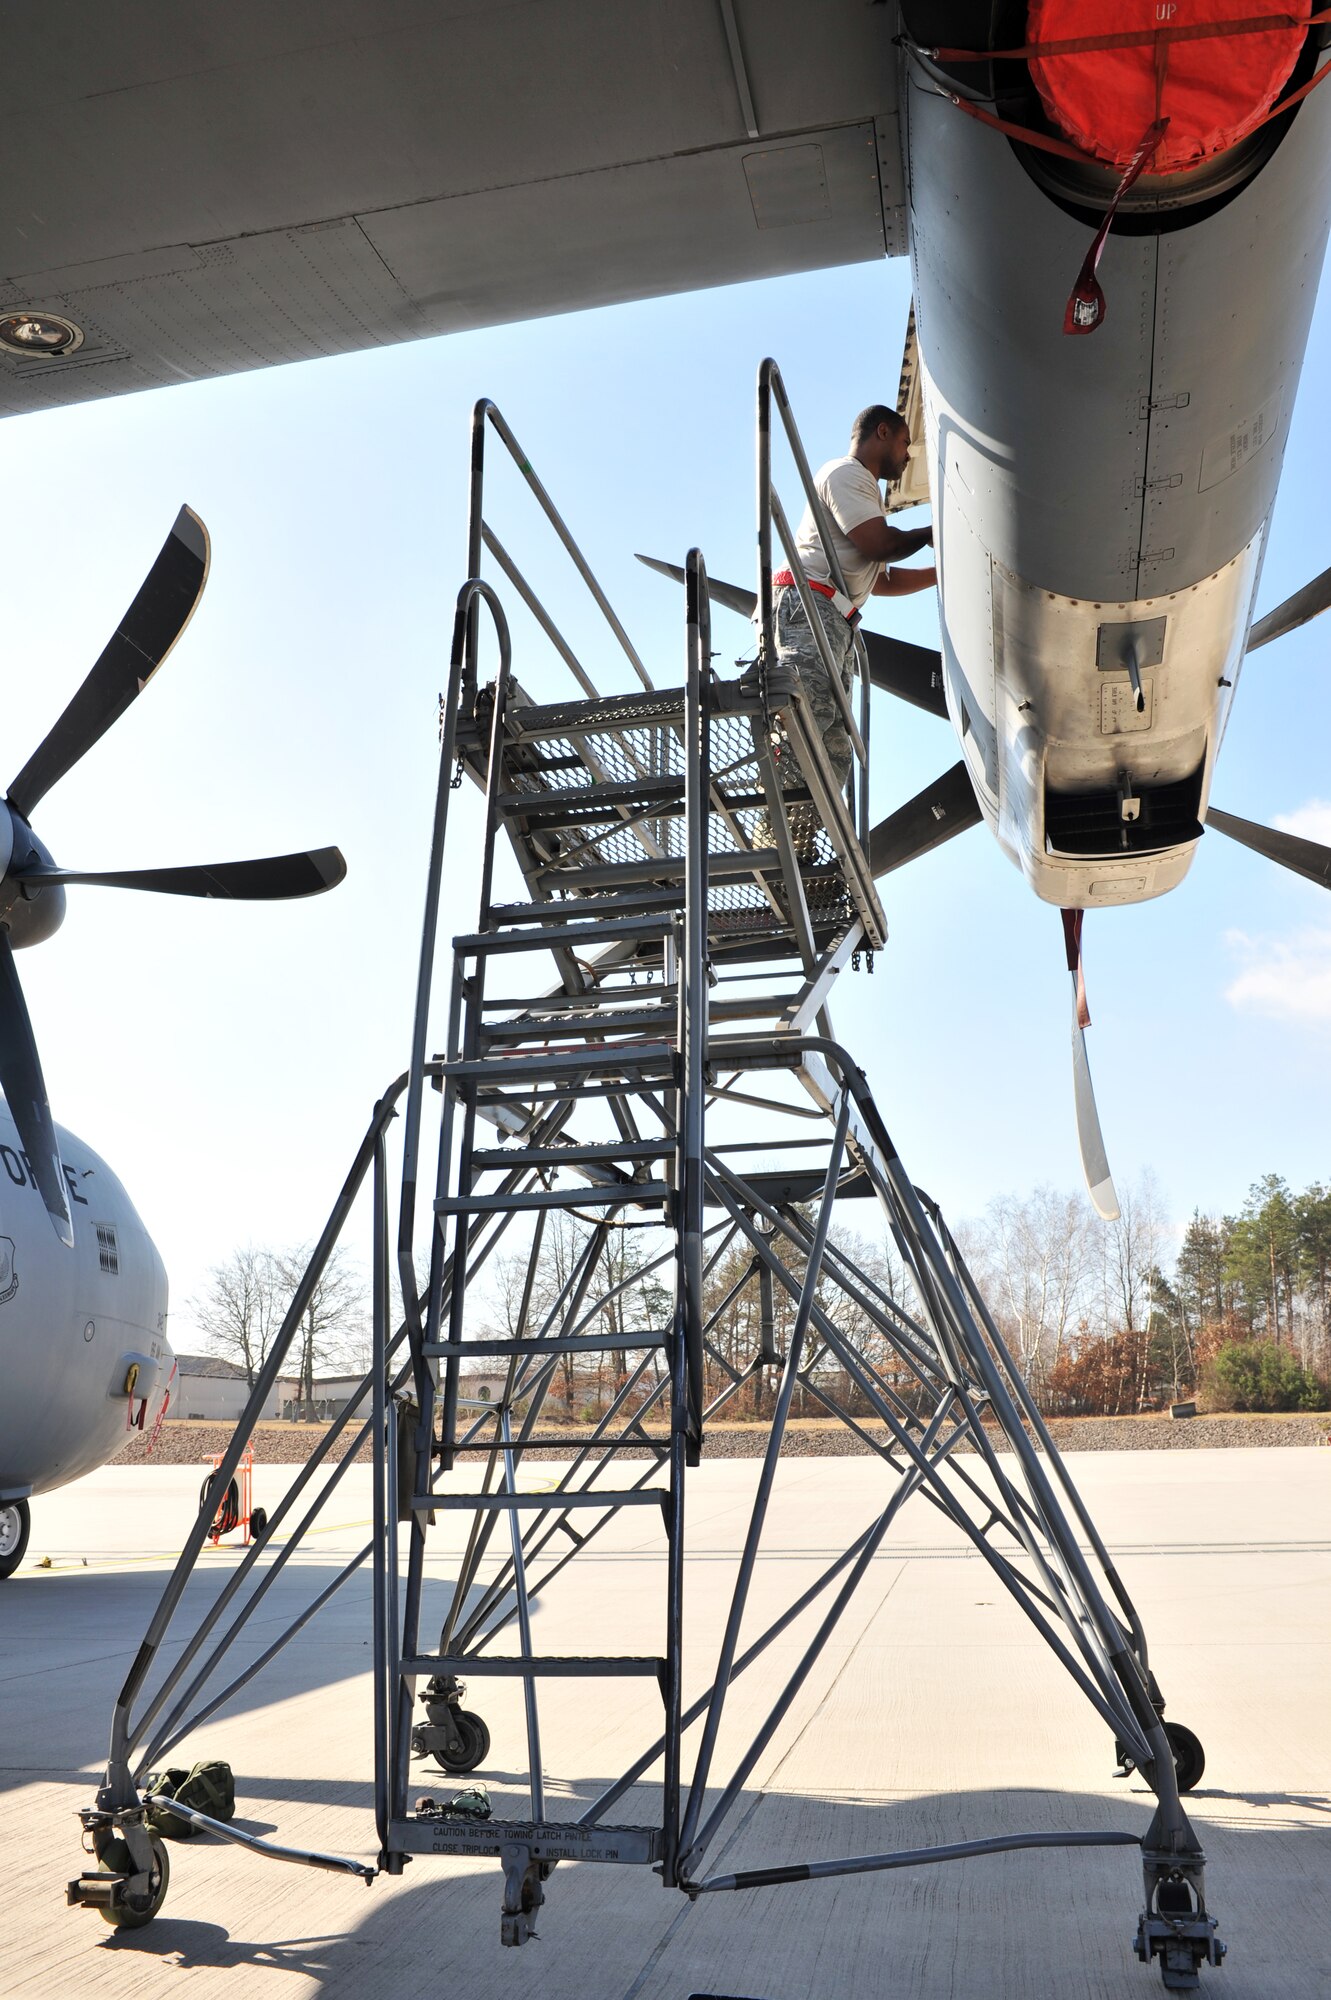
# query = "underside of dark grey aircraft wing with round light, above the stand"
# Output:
<box><xmin>0</xmin><ymin>0</ymin><xmax>905</xmax><ymax>414</ymax></box>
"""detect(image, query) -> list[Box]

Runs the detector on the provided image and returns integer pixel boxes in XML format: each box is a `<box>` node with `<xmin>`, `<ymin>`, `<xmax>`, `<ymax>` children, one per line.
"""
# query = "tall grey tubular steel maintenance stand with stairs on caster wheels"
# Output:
<box><xmin>70</xmin><ymin>376</ymin><xmax>1223</xmax><ymax>1986</ymax></box>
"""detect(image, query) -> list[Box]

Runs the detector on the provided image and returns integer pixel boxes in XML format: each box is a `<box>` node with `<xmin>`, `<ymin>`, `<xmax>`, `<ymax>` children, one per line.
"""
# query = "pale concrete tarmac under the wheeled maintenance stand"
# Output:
<box><xmin>0</xmin><ymin>1448</ymin><xmax>1331</xmax><ymax>2000</ymax></box>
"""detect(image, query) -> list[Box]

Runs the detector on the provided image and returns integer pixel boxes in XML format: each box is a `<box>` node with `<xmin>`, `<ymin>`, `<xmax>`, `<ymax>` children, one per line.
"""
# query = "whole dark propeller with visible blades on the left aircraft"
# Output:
<box><xmin>0</xmin><ymin>506</ymin><xmax>346</xmax><ymax>1246</ymax></box>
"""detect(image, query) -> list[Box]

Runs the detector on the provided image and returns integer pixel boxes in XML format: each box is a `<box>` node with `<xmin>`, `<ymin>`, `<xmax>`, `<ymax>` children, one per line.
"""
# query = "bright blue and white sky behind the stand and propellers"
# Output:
<box><xmin>4</xmin><ymin>262</ymin><xmax>1331</xmax><ymax>1346</ymax></box>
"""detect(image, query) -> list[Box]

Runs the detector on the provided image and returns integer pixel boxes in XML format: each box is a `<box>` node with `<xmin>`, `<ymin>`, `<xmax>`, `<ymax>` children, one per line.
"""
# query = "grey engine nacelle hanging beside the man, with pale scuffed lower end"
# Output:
<box><xmin>901</xmin><ymin>6</ymin><xmax>1331</xmax><ymax>908</ymax></box>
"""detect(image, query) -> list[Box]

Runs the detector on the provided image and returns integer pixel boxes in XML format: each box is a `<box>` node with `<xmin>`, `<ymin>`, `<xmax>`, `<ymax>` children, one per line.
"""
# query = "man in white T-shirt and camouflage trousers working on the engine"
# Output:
<box><xmin>771</xmin><ymin>402</ymin><xmax>937</xmax><ymax>808</ymax></box>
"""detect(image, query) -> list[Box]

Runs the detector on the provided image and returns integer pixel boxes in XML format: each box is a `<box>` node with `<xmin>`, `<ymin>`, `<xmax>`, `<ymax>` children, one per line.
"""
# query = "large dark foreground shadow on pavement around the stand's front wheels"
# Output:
<box><xmin>80</xmin><ymin>1782</ymin><xmax>1331</xmax><ymax>2000</ymax></box>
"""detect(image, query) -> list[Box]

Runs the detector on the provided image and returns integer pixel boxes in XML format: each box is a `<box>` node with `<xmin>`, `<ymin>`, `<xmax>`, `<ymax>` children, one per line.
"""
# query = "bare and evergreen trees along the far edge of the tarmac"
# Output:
<box><xmin>192</xmin><ymin>1174</ymin><xmax>1331</xmax><ymax>1422</ymax></box>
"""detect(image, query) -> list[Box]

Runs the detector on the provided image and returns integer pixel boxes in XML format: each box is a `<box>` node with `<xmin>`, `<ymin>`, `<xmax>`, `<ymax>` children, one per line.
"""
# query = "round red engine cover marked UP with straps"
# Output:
<box><xmin>1027</xmin><ymin>0</ymin><xmax>1313</xmax><ymax>174</ymax></box>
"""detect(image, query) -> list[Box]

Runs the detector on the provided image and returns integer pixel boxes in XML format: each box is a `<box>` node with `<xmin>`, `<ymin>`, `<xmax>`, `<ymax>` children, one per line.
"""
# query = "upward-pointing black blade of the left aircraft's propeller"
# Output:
<box><xmin>10</xmin><ymin>506</ymin><xmax>208</xmax><ymax>820</ymax></box>
